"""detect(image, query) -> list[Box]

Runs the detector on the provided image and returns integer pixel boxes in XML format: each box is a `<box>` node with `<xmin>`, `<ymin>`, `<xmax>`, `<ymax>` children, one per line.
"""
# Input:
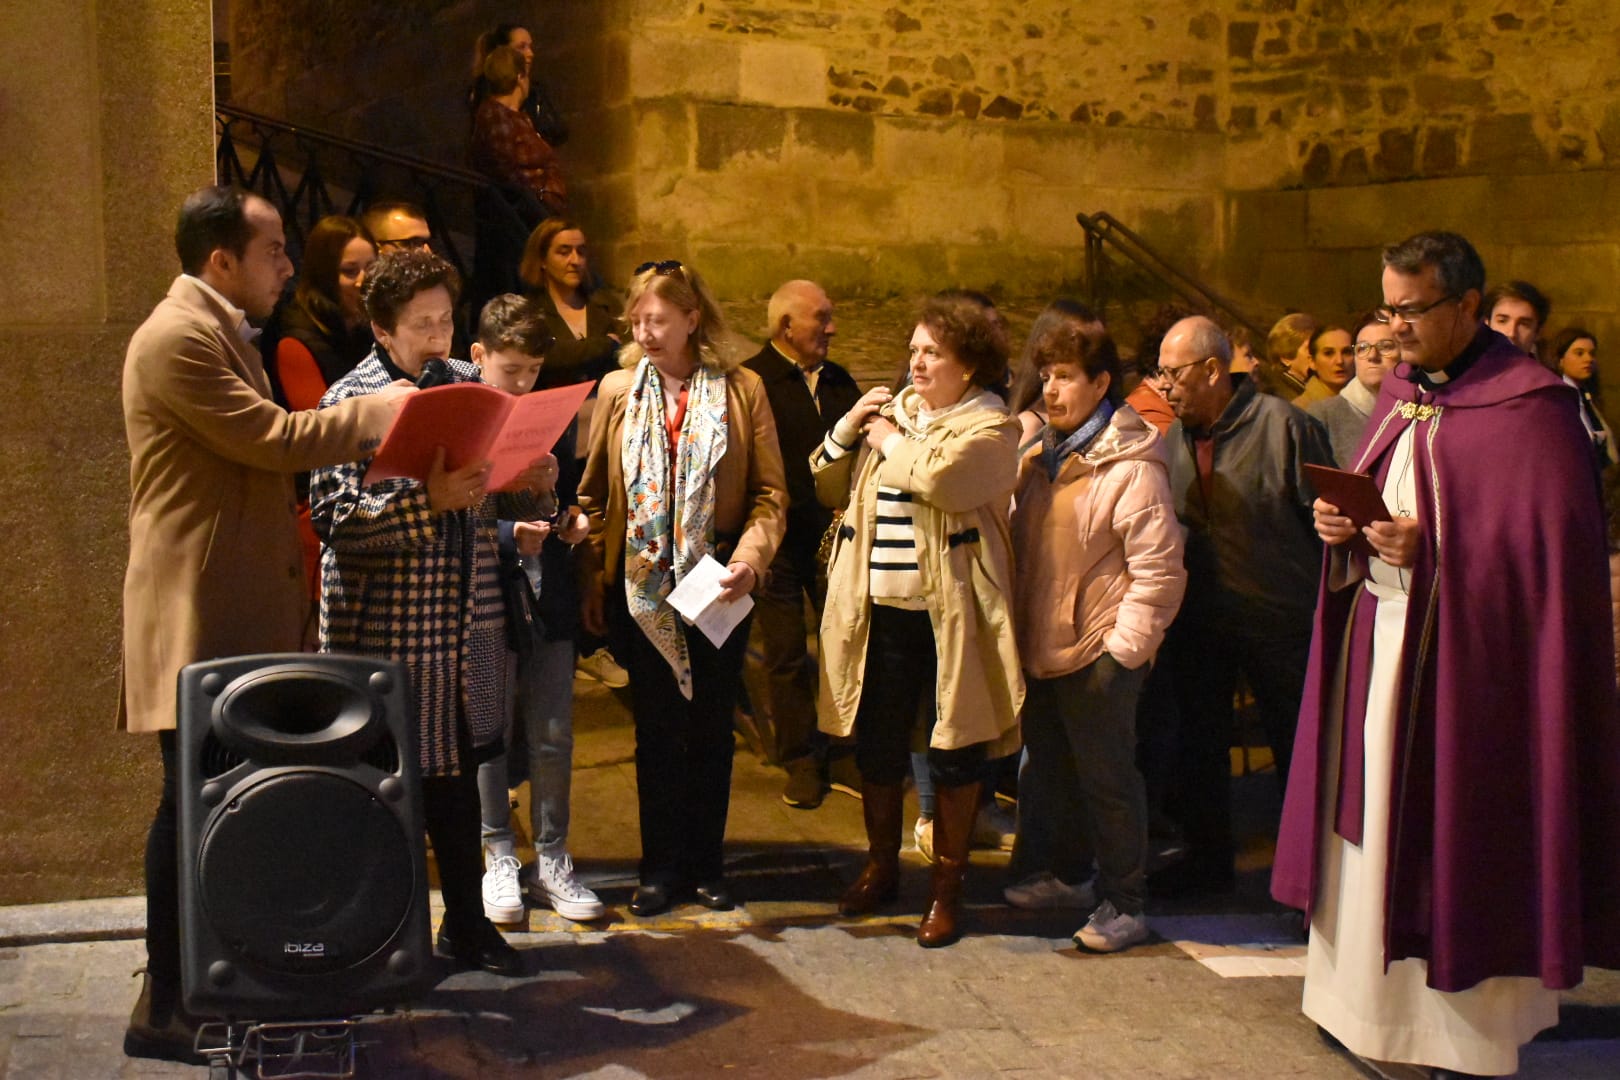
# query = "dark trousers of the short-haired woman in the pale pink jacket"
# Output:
<box><xmin>1009</xmin><ymin>653</ymin><xmax>1147</xmax><ymax>915</ymax></box>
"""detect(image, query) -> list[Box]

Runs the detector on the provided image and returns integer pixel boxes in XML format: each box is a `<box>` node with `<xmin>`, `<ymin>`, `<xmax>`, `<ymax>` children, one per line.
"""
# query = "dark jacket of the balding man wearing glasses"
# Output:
<box><xmin>1166</xmin><ymin>376</ymin><xmax>1333</xmax><ymax>623</ymax></box>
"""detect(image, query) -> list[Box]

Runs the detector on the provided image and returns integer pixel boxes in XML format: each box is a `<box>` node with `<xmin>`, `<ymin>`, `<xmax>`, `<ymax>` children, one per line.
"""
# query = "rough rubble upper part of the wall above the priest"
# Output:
<box><xmin>1218</xmin><ymin>0</ymin><xmax>1620</xmax><ymax>188</ymax></box>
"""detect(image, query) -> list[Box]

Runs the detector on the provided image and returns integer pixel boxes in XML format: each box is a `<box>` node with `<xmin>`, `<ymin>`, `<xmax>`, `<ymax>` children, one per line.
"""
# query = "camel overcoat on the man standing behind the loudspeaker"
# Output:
<box><xmin>118</xmin><ymin>275</ymin><xmax>392</xmax><ymax>732</ymax></box>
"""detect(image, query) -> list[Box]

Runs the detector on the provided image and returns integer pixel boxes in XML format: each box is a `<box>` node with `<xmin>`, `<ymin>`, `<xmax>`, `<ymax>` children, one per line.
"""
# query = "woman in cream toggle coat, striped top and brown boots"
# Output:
<box><xmin>810</xmin><ymin>293</ymin><xmax>1024</xmax><ymax>949</ymax></box>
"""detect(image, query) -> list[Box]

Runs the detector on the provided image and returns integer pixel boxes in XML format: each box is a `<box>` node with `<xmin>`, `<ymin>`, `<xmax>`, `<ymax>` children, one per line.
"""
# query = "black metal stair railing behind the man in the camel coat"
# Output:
<box><xmin>214</xmin><ymin>104</ymin><xmax>528</xmax><ymax>280</ymax></box>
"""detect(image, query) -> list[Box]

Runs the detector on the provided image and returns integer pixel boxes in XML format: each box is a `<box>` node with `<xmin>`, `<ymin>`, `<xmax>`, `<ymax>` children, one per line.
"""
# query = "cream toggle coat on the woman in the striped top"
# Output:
<box><xmin>810</xmin><ymin>397</ymin><xmax>1024</xmax><ymax>756</ymax></box>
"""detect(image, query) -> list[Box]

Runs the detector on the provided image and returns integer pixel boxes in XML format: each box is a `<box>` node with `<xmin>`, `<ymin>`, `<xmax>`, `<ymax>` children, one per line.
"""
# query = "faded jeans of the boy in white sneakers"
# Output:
<box><xmin>478</xmin><ymin>638</ymin><xmax>573</xmax><ymax>850</ymax></box>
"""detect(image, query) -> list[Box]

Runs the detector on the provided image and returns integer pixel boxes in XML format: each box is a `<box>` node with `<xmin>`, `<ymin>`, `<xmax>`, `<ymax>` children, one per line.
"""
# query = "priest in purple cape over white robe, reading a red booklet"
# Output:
<box><xmin>1272</xmin><ymin>233</ymin><xmax>1620</xmax><ymax>1075</ymax></box>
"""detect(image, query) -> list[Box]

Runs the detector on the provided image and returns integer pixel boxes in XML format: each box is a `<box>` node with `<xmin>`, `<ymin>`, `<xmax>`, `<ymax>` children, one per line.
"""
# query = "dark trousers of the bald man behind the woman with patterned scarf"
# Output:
<box><xmin>744</xmin><ymin>542</ymin><xmax>826</xmax><ymax>764</ymax></box>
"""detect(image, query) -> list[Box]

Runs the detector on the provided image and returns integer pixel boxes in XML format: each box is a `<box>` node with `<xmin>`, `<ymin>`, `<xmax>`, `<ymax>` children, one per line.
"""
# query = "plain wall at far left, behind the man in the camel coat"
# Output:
<box><xmin>0</xmin><ymin>0</ymin><xmax>214</xmax><ymax>904</ymax></box>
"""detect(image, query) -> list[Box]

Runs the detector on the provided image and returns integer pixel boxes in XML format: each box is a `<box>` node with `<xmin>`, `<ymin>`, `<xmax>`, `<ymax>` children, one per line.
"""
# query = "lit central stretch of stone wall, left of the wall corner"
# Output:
<box><xmin>543</xmin><ymin>0</ymin><xmax>1225</xmax><ymax>296</ymax></box>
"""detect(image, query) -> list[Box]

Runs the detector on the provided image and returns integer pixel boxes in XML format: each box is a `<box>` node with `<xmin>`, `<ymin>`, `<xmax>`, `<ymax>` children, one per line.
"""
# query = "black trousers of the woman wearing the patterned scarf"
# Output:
<box><xmin>609</xmin><ymin>583</ymin><xmax>750</xmax><ymax>887</ymax></box>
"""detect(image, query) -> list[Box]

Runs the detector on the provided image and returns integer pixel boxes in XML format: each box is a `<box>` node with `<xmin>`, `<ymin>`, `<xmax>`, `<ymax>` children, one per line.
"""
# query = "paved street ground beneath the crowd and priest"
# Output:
<box><xmin>0</xmin><ymin>680</ymin><xmax>1620</xmax><ymax>1080</ymax></box>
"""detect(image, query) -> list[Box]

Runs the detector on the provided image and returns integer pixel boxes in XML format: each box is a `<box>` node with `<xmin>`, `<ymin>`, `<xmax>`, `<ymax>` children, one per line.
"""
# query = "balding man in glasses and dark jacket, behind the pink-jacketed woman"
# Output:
<box><xmin>1150</xmin><ymin>316</ymin><xmax>1333</xmax><ymax>895</ymax></box>
